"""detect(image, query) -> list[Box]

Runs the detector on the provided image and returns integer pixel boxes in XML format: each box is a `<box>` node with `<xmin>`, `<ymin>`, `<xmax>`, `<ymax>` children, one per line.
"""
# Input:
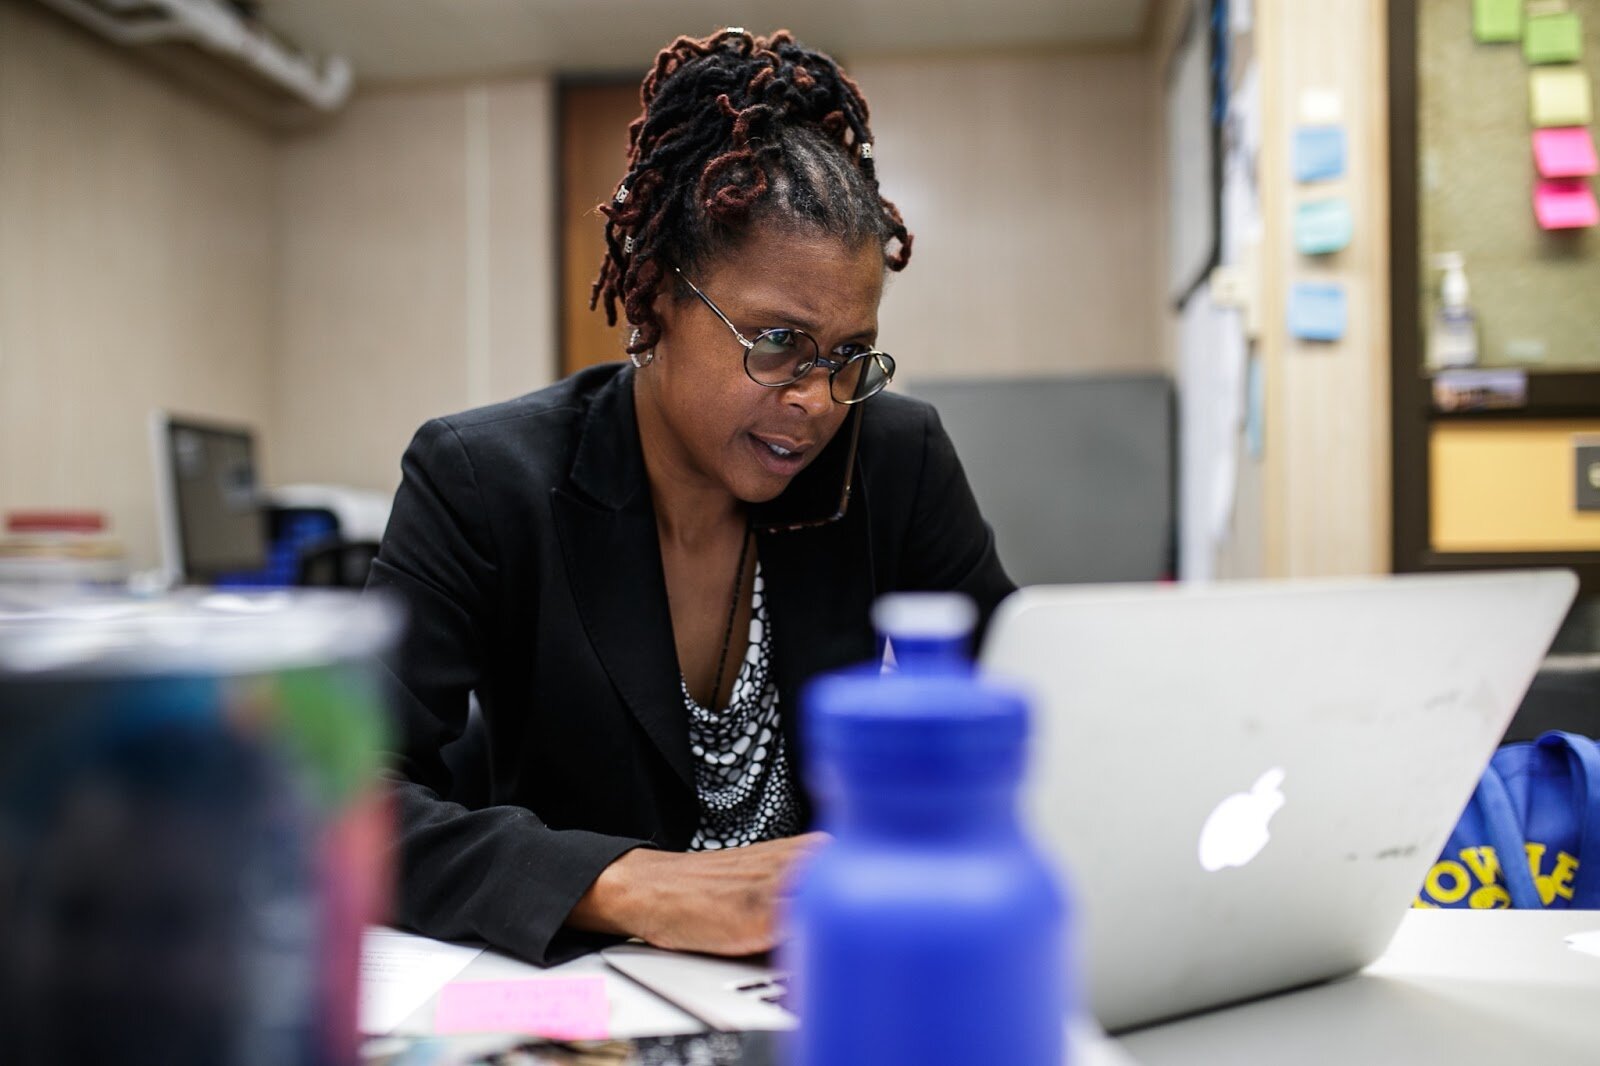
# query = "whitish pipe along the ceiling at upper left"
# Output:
<box><xmin>40</xmin><ymin>0</ymin><xmax>354</xmax><ymax>110</ymax></box>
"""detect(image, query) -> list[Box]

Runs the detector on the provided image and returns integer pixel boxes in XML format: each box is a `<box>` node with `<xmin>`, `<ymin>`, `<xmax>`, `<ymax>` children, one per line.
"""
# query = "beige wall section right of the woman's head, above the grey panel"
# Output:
<box><xmin>848</xmin><ymin>51</ymin><xmax>1165</xmax><ymax>383</ymax></box>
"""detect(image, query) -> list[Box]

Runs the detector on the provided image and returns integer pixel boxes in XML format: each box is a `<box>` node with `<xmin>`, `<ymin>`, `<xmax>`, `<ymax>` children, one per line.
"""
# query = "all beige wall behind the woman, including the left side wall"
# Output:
<box><xmin>0</xmin><ymin>16</ymin><xmax>1165</xmax><ymax>565</ymax></box>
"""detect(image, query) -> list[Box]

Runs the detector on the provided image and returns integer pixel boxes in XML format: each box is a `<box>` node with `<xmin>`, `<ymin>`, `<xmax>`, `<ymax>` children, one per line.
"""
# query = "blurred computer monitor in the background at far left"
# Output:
<box><xmin>150</xmin><ymin>411</ymin><xmax>267</xmax><ymax>584</ymax></box>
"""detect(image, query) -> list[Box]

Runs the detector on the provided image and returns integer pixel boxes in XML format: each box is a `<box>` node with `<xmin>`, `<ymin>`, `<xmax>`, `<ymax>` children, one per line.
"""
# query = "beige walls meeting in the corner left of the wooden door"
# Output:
<box><xmin>0</xmin><ymin>3</ymin><xmax>555</xmax><ymax>568</ymax></box>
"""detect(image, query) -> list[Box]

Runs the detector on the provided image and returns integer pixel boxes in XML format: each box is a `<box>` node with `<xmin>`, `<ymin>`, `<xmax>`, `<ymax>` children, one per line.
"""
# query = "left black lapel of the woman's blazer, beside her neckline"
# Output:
<box><xmin>552</xmin><ymin>370</ymin><xmax>694</xmax><ymax>789</ymax></box>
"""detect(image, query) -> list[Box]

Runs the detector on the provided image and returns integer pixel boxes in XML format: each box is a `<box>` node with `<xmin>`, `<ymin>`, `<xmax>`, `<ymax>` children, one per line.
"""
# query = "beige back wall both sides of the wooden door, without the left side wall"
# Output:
<box><xmin>272</xmin><ymin>53</ymin><xmax>1163</xmax><ymax>490</ymax></box>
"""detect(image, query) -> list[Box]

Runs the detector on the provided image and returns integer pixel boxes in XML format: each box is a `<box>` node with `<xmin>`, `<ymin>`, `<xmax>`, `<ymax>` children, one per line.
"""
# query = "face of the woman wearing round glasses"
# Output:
<box><xmin>638</xmin><ymin>226</ymin><xmax>883</xmax><ymax>503</ymax></box>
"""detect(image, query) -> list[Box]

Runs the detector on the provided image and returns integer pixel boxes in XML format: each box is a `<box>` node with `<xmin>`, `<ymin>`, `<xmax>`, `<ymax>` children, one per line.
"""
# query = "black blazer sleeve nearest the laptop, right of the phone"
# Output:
<box><xmin>899</xmin><ymin>407</ymin><xmax>1016</xmax><ymax>640</ymax></box>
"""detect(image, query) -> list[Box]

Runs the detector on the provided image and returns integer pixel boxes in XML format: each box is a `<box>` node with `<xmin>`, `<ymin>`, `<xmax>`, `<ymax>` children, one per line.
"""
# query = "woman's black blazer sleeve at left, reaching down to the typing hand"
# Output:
<box><xmin>366</xmin><ymin>419</ymin><xmax>645</xmax><ymax>965</ymax></box>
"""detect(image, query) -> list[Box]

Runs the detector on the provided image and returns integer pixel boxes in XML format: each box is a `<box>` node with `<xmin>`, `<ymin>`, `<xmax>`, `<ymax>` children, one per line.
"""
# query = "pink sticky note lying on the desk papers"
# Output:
<box><xmin>434</xmin><ymin>975</ymin><xmax>610</xmax><ymax>1040</ymax></box>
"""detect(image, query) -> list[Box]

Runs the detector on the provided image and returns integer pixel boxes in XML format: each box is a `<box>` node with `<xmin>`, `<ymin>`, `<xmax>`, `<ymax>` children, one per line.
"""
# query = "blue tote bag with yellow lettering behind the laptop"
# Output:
<box><xmin>1414</xmin><ymin>733</ymin><xmax>1600</xmax><ymax>909</ymax></box>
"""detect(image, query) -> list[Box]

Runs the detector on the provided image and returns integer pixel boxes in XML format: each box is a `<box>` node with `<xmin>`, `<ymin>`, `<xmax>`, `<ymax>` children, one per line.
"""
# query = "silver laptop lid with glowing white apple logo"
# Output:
<box><xmin>981</xmin><ymin>571</ymin><xmax>1576</xmax><ymax>1029</ymax></box>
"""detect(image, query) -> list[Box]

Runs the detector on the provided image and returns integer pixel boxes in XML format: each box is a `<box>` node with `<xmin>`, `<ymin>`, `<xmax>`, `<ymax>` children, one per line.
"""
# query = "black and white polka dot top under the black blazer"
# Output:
<box><xmin>678</xmin><ymin>560</ymin><xmax>800</xmax><ymax>852</ymax></box>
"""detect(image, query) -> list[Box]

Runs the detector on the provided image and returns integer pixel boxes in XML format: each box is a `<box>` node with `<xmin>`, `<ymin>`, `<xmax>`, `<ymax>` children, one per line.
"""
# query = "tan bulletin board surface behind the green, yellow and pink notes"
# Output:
<box><xmin>1420</xmin><ymin>0</ymin><xmax>1600</xmax><ymax>371</ymax></box>
